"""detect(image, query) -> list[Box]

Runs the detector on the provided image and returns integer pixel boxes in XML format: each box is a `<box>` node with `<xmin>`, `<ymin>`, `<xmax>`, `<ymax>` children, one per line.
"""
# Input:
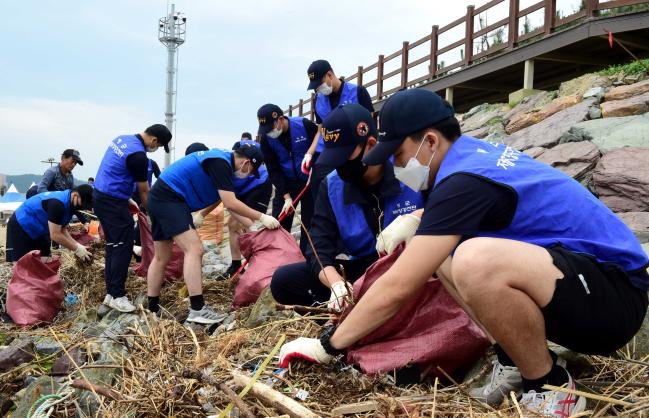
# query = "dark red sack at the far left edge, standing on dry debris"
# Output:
<box><xmin>7</xmin><ymin>251</ymin><xmax>65</xmax><ymax>326</ymax></box>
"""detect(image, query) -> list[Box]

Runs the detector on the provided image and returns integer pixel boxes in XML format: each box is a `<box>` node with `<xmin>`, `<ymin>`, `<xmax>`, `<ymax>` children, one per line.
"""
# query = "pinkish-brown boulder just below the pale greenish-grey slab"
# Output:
<box><xmin>536</xmin><ymin>141</ymin><xmax>600</xmax><ymax>180</ymax></box>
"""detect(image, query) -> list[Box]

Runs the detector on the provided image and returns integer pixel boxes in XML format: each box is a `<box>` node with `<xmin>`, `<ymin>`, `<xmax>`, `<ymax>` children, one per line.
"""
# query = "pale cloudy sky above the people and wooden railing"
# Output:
<box><xmin>0</xmin><ymin>0</ymin><xmax>584</xmax><ymax>184</ymax></box>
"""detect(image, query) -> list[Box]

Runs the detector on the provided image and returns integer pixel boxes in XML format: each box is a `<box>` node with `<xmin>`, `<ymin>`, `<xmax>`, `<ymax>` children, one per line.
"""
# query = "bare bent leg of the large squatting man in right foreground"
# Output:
<box><xmin>451</xmin><ymin>238</ymin><xmax>563</xmax><ymax>379</ymax></box>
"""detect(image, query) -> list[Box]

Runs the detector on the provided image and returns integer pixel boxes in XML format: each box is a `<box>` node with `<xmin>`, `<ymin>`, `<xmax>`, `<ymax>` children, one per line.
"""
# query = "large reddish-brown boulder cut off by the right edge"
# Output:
<box><xmin>593</xmin><ymin>147</ymin><xmax>649</xmax><ymax>212</ymax></box>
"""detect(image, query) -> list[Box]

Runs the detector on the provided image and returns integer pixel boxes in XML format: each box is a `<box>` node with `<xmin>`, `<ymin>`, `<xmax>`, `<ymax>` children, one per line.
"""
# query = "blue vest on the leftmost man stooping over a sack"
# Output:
<box><xmin>16</xmin><ymin>190</ymin><xmax>72</xmax><ymax>239</ymax></box>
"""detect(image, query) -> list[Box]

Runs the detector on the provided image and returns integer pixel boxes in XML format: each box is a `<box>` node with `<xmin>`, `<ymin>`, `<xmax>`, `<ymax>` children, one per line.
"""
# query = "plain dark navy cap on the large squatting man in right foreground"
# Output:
<box><xmin>363</xmin><ymin>89</ymin><xmax>455</xmax><ymax>165</ymax></box>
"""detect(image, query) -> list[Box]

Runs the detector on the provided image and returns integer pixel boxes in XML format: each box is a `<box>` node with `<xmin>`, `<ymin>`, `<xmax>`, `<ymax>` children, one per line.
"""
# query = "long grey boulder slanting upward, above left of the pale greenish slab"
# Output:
<box><xmin>503</xmin><ymin>99</ymin><xmax>596</xmax><ymax>151</ymax></box>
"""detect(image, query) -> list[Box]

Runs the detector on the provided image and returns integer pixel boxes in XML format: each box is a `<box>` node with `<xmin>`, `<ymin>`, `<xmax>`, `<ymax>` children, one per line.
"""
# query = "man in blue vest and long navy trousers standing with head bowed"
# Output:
<box><xmin>93</xmin><ymin>124</ymin><xmax>171</xmax><ymax>312</ymax></box>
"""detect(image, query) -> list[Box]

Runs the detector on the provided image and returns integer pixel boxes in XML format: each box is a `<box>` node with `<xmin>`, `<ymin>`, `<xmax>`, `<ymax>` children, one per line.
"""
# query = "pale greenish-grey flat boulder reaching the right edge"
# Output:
<box><xmin>561</xmin><ymin>114</ymin><xmax>649</xmax><ymax>152</ymax></box>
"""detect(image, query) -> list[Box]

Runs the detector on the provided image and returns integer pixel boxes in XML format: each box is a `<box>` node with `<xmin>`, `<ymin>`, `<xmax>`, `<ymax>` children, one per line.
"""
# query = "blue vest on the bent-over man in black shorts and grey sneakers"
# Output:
<box><xmin>160</xmin><ymin>148</ymin><xmax>232</xmax><ymax>212</ymax></box>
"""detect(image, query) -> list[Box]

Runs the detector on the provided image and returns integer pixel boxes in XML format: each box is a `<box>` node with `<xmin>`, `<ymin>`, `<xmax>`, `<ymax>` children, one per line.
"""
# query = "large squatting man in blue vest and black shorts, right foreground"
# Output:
<box><xmin>278</xmin><ymin>89</ymin><xmax>649</xmax><ymax>417</ymax></box>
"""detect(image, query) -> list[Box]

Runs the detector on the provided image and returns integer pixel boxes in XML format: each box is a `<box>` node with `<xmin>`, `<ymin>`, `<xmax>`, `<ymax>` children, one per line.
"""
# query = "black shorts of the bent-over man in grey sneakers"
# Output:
<box><xmin>147</xmin><ymin>179</ymin><xmax>195</xmax><ymax>241</ymax></box>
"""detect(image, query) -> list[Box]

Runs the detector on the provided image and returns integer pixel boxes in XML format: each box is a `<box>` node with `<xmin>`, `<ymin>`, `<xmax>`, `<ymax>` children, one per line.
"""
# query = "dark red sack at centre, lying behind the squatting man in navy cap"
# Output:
<box><xmin>233</xmin><ymin>228</ymin><xmax>304</xmax><ymax>308</ymax></box>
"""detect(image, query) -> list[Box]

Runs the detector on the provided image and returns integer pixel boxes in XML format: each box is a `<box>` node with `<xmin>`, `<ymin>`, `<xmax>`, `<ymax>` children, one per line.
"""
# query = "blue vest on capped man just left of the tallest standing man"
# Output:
<box><xmin>266</xmin><ymin>117</ymin><xmax>313</xmax><ymax>182</ymax></box>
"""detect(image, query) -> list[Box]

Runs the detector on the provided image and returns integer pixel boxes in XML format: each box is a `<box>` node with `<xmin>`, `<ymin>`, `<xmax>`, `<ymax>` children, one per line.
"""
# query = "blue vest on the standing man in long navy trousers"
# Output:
<box><xmin>95</xmin><ymin>135</ymin><xmax>146</xmax><ymax>200</ymax></box>
